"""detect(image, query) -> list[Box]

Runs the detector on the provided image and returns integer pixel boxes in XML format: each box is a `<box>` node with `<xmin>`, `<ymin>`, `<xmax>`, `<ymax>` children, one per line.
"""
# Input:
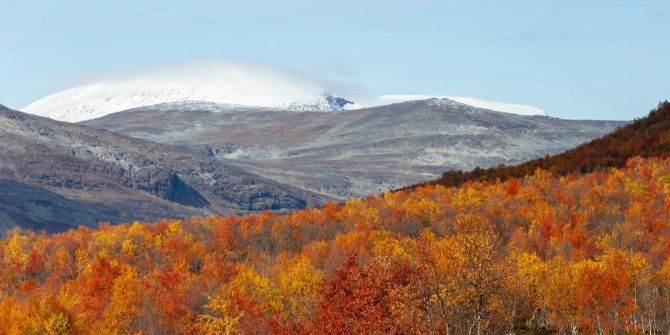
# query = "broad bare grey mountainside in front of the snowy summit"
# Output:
<box><xmin>84</xmin><ymin>99</ymin><xmax>625</xmax><ymax>199</ymax></box>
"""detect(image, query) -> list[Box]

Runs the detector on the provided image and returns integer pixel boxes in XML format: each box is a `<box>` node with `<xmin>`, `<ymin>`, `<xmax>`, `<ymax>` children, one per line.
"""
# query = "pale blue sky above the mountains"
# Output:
<box><xmin>0</xmin><ymin>0</ymin><xmax>670</xmax><ymax>119</ymax></box>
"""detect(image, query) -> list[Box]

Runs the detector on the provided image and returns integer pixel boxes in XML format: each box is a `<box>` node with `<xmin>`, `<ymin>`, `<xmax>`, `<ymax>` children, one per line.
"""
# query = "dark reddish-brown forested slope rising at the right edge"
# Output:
<box><xmin>434</xmin><ymin>101</ymin><xmax>670</xmax><ymax>186</ymax></box>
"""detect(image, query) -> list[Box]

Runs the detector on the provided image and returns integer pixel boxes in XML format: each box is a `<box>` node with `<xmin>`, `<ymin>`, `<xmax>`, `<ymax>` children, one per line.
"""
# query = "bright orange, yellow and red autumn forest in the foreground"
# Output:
<box><xmin>0</xmin><ymin>104</ymin><xmax>670</xmax><ymax>334</ymax></box>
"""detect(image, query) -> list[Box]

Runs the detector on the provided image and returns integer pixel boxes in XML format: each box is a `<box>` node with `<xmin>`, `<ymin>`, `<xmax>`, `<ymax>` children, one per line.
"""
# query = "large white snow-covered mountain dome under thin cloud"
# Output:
<box><xmin>21</xmin><ymin>61</ymin><xmax>357</xmax><ymax>122</ymax></box>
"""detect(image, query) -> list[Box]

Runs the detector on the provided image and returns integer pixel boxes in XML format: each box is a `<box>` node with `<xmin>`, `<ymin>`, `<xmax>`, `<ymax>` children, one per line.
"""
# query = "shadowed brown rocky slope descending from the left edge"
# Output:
<box><xmin>0</xmin><ymin>106</ymin><xmax>325</xmax><ymax>231</ymax></box>
